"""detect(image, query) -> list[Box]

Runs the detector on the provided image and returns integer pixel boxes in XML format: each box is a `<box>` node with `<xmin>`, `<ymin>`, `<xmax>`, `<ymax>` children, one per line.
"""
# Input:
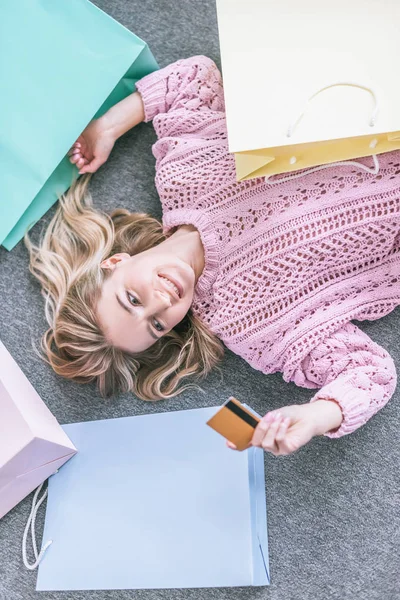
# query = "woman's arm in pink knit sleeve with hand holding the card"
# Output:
<box><xmin>238</xmin><ymin>323</ymin><xmax>397</xmax><ymax>456</ymax></box>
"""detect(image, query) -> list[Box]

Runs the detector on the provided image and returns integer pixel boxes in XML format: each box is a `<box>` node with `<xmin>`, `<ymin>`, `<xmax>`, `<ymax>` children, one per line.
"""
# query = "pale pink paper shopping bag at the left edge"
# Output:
<box><xmin>0</xmin><ymin>342</ymin><xmax>76</xmax><ymax>519</ymax></box>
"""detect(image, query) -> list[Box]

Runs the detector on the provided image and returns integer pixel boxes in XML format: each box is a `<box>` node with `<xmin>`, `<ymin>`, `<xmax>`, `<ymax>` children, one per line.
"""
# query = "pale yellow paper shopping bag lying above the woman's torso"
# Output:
<box><xmin>217</xmin><ymin>0</ymin><xmax>400</xmax><ymax>181</ymax></box>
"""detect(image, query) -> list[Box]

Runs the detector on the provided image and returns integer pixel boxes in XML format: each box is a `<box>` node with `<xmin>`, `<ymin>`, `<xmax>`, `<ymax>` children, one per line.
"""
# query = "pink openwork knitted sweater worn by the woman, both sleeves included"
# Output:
<box><xmin>137</xmin><ymin>56</ymin><xmax>400</xmax><ymax>437</ymax></box>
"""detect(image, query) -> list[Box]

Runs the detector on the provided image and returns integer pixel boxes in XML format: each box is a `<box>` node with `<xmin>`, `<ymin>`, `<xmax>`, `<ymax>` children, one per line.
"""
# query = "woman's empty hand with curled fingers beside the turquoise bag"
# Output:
<box><xmin>68</xmin><ymin>119</ymin><xmax>116</xmax><ymax>174</ymax></box>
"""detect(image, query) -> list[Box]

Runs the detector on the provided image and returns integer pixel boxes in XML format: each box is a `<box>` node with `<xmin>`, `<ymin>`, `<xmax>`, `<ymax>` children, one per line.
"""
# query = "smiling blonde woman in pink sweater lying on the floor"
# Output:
<box><xmin>27</xmin><ymin>56</ymin><xmax>400</xmax><ymax>455</ymax></box>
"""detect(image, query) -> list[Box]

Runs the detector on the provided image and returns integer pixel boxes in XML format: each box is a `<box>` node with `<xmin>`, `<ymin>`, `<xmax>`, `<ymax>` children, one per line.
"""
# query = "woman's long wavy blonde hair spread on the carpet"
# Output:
<box><xmin>25</xmin><ymin>175</ymin><xmax>223</xmax><ymax>400</ymax></box>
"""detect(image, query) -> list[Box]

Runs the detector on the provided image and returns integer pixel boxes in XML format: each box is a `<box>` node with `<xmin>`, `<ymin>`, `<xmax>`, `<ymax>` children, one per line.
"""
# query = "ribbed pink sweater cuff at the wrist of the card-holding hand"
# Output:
<box><xmin>310</xmin><ymin>380</ymin><xmax>370</xmax><ymax>438</ymax></box>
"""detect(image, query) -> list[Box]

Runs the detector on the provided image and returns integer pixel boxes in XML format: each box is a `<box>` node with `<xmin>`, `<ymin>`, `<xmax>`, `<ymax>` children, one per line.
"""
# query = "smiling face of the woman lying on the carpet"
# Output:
<box><xmin>97</xmin><ymin>245</ymin><xmax>196</xmax><ymax>353</ymax></box>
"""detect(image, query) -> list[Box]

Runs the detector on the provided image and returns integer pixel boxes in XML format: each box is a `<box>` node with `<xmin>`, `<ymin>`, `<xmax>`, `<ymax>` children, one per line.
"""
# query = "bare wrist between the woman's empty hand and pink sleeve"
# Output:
<box><xmin>99</xmin><ymin>92</ymin><xmax>144</xmax><ymax>140</ymax></box>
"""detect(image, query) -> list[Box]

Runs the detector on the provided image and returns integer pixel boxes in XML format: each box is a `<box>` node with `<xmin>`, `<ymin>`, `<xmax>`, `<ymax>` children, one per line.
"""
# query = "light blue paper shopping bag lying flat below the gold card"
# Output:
<box><xmin>36</xmin><ymin>408</ymin><xmax>270</xmax><ymax>591</ymax></box>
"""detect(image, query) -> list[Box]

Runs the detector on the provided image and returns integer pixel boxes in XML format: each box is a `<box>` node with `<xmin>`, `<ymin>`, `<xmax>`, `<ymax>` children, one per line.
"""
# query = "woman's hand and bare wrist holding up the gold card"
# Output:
<box><xmin>227</xmin><ymin>400</ymin><xmax>343</xmax><ymax>456</ymax></box>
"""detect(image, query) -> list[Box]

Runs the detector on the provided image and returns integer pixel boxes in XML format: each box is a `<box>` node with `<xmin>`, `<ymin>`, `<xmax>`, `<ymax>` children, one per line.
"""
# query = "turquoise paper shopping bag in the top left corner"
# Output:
<box><xmin>0</xmin><ymin>0</ymin><xmax>158</xmax><ymax>250</ymax></box>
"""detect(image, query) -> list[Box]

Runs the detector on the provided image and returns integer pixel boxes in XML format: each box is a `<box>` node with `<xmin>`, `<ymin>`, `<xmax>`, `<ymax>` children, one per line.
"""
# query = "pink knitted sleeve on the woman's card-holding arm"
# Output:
<box><xmin>284</xmin><ymin>323</ymin><xmax>397</xmax><ymax>438</ymax></box>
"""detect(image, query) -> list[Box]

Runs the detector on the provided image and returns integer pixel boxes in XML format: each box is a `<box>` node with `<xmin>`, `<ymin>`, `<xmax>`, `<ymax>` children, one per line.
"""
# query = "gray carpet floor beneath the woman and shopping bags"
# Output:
<box><xmin>0</xmin><ymin>0</ymin><xmax>400</xmax><ymax>600</ymax></box>
